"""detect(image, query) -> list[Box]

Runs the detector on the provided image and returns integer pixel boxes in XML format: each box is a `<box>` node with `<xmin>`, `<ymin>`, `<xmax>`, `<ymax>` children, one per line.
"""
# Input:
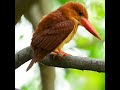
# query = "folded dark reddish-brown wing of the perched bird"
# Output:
<box><xmin>31</xmin><ymin>20</ymin><xmax>74</xmax><ymax>51</ymax></box>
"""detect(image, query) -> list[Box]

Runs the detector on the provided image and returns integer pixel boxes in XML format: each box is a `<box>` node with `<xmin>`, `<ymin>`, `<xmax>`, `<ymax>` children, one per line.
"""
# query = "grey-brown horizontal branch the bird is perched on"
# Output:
<box><xmin>15</xmin><ymin>47</ymin><xmax>105</xmax><ymax>72</ymax></box>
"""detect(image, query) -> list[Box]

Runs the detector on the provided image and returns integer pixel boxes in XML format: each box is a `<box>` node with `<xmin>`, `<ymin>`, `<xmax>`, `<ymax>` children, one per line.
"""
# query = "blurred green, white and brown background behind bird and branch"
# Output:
<box><xmin>15</xmin><ymin>0</ymin><xmax>105</xmax><ymax>90</ymax></box>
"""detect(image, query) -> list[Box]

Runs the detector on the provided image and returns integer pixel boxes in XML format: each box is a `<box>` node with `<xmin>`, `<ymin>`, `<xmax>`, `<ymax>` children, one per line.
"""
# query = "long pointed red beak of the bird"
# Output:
<box><xmin>81</xmin><ymin>17</ymin><xmax>101</xmax><ymax>40</ymax></box>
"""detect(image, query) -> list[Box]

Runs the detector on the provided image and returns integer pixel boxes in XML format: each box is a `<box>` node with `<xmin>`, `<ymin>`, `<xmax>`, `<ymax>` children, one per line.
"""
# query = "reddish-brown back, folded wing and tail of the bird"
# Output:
<box><xmin>27</xmin><ymin>10</ymin><xmax>74</xmax><ymax>70</ymax></box>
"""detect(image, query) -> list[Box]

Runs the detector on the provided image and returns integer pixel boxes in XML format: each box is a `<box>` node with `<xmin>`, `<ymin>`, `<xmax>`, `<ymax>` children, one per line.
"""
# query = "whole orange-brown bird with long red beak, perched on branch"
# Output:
<box><xmin>27</xmin><ymin>2</ymin><xmax>101</xmax><ymax>71</ymax></box>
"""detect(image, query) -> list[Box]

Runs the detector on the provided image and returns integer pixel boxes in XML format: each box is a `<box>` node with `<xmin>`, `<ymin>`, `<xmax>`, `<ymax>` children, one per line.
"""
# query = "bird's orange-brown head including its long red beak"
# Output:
<box><xmin>61</xmin><ymin>2</ymin><xmax>101</xmax><ymax>40</ymax></box>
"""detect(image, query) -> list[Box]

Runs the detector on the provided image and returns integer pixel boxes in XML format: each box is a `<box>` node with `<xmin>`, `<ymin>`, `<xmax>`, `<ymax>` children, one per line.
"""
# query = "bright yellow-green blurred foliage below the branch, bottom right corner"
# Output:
<box><xmin>65</xmin><ymin>69</ymin><xmax>105</xmax><ymax>90</ymax></box>
